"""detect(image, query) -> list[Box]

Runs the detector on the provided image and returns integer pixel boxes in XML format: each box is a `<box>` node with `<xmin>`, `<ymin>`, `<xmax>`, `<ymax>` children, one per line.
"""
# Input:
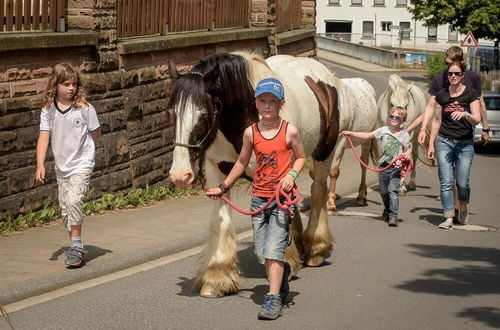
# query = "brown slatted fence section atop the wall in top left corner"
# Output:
<box><xmin>0</xmin><ymin>0</ymin><xmax>66</xmax><ymax>32</ymax></box>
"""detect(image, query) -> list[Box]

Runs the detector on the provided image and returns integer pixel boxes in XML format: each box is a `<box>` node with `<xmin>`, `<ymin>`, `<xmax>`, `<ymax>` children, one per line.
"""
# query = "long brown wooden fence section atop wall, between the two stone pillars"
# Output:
<box><xmin>117</xmin><ymin>0</ymin><xmax>251</xmax><ymax>37</ymax></box>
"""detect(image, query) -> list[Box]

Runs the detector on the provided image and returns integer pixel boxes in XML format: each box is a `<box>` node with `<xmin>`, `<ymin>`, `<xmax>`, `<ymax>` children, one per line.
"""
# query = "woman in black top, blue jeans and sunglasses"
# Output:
<box><xmin>428</xmin><ymin>62</ymin><xmax>481</xmax><ymax>229</ymax></box>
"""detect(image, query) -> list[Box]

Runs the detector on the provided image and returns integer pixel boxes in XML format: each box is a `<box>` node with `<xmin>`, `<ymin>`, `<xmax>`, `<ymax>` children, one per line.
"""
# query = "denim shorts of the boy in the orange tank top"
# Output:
<box><xmin>250</xmin><ymin>195</ymin><xmax>293</xmax><ymax>264</ymax></box>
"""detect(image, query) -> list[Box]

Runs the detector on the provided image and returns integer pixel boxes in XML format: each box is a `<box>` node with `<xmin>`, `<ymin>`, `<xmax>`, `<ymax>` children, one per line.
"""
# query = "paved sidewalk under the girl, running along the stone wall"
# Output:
<box><xmin>0</xmin><ymin>150</ymin><xmax>377</xmax><ymax>305</ymax></box>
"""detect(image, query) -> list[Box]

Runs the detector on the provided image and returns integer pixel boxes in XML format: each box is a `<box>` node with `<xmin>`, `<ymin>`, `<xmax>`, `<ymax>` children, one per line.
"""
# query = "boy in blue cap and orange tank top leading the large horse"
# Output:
<box><xmin>206</xmin><ymin>78</ymin><xmax>306</xmax><ymax>320</ymax></box>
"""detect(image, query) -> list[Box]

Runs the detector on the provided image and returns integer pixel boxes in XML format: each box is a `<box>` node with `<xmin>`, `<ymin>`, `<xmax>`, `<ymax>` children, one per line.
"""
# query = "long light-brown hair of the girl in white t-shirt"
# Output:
<box><xmin>43</xmin><ymin>63</ymin><xmax>87</xmax><ymax>108</ymax></box>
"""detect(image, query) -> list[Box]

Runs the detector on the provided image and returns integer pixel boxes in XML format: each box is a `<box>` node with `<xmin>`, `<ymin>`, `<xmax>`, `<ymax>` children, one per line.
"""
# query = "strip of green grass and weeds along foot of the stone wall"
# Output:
<box><xmin>0</xmin><ymin>185</ymin><xmax>199</xmax><ymax>235</ymax></box>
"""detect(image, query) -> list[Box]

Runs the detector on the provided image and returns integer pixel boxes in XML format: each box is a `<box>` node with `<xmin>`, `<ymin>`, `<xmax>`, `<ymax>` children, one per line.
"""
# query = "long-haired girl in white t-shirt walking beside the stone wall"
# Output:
<box><xmin>35</xmin><ymin>63</ymin><xmax>101</xmax><ymax>267</ymax></box>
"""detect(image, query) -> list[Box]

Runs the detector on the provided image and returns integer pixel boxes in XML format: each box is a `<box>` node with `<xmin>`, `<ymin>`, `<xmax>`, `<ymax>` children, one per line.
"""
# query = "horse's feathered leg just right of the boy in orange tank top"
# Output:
<box><xmin>302</xmin><ymin>161</ymin><xmax>334</xmax><ymax>267</ymax></box>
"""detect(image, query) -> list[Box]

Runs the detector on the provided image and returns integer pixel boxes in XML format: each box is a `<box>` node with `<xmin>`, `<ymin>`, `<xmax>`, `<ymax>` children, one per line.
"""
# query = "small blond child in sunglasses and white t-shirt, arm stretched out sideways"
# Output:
<box><xmin>340</xmin><ymin>107</ymin><xmax>412</xmax><ymax>227</ymax></box>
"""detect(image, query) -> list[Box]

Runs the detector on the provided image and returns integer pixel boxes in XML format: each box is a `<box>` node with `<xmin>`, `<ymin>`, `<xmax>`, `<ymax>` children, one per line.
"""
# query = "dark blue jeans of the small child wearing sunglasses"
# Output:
<box><xmin>378</xmin><ymin>163</ymin><xmax>401</xmax><ymax>217</ymax></box>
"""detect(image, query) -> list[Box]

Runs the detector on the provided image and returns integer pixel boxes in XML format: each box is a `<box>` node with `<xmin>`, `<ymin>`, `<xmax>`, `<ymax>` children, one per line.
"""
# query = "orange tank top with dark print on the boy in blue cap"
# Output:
<box><xmin>252</xmin><ymin>120</ymin><xmax>292</xmax><ymax>197</ymax></box>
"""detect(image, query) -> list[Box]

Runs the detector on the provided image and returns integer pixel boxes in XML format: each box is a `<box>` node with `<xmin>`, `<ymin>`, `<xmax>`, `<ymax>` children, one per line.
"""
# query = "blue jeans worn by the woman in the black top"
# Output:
<box><xmin>436</xmin><ymin>136</ymin><xmax>474</xmax><ymax>218</ymax></box>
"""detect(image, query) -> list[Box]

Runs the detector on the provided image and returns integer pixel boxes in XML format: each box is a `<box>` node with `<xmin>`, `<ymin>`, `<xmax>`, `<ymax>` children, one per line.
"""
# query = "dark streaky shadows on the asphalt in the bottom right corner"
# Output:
<box><xmin>396</xmin><ymin>244</ymin><xmax>500</xmax><ymax>327</ymax></box>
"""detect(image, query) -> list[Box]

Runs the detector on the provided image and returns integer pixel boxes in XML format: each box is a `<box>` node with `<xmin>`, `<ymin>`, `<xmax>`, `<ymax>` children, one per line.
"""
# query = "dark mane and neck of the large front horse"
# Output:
<box><xmin>167</xmin><ymin>52</ymin><xmax>267</xmax><ymax>151</ymax></box>
